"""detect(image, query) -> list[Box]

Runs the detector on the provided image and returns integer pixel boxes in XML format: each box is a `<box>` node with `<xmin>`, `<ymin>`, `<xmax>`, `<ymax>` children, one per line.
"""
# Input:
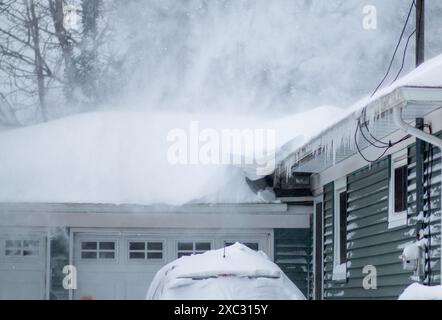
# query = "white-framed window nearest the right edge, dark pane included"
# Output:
<box><xmin>388</xmin><ymin>149</ymin><xmax>408</xmax><ymax>228</ymax></box>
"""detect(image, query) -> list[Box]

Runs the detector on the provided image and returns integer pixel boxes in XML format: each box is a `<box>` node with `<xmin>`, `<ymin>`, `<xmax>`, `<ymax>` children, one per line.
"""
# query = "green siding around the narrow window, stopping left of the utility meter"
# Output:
<box><xmin>324</xmin><ymin>158</ymin><xmax>415</xmax><ymax>299</ymax></box>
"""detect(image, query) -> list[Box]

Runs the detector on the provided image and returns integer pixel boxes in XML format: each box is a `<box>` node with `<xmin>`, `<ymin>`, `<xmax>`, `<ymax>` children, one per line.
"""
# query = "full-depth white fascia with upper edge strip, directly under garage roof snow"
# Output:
<box><xmin>0</xmin><ymin>203</ymin><xmax>312</xmax><ymax>229</ymax></box>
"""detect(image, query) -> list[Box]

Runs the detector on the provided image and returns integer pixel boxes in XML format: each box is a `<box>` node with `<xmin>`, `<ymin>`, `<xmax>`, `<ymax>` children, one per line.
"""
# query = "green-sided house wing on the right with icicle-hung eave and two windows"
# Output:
<box><xmin>275</xmin><ymin>56</ymin><xmax>442</xmax><ymax>299</ymax></box>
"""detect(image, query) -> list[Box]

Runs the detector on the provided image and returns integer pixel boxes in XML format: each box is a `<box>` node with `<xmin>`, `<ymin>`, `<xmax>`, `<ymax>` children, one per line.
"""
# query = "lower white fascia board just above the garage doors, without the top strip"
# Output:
<box><xmin>0</xmin><ymin>212</ymin><xmax>310</xmax><ymax>229</ymax></box>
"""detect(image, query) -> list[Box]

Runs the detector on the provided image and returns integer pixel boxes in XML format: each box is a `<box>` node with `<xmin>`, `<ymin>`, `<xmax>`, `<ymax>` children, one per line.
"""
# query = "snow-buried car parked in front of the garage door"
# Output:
<box><xmin>147</xmin><ymin>243</ymin><xmax>305</xmax><ymax>300</ymax></box>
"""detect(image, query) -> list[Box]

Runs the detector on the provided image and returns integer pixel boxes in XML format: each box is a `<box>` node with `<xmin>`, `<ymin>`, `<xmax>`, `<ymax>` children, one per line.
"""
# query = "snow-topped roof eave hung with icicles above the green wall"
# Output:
<box><xmin>279</xmin><ymin>55</ymin><xmax>442</xmax><ymax>172</ymax></box>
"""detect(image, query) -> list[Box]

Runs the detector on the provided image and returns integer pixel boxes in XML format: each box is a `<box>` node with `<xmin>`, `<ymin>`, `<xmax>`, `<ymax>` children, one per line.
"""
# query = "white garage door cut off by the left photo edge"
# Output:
<box><xmin>0</xmin><ymin>231</ymin><xmax>46</xmax><ymax>299</ymax></box>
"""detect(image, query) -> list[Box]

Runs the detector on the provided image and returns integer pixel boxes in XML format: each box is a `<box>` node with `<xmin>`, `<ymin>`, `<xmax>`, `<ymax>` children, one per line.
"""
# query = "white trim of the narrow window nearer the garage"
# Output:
<box><xmin>332</xmin><ymin>177</ymin><xmax>347</xmax><ymax>281</ymax></box>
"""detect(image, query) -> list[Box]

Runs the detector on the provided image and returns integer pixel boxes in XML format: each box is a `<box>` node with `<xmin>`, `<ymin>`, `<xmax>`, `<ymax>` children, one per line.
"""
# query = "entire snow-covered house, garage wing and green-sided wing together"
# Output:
<box><xmin>0</xmin><ymin>57</ymin><xmax>442</xmax><ymax>299</ymax></box>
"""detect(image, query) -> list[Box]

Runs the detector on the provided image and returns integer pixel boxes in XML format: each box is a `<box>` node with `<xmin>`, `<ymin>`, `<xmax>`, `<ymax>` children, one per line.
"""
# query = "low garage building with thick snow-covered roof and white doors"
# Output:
<box><xmin>0</xmin><ymin>111</ymin><xmax>322</xmax><ymax>299</ymax></box>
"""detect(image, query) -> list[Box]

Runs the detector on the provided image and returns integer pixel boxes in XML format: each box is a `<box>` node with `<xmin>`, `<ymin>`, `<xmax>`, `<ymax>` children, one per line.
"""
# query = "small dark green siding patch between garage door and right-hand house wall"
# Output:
<box><xmin>274</xmin><ymin>229</ymin><xmax>311</xmax><ymax>297</ymax></box>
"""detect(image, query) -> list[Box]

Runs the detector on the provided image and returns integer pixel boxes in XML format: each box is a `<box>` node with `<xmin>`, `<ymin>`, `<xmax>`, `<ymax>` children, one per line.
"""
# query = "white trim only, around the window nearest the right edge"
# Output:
<box><xmin>388</xmin><ymin>149</ymin><xmax>408</xmax><ymax>229</ymax></box>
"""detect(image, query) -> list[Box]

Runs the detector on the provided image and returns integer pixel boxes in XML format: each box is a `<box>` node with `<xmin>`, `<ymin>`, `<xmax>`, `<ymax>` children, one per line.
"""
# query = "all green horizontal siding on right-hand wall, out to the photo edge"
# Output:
<box><xmin>323</xmin><ymin>133</ymin><xmax>442</xmax><ymax>299</ymax></box>
